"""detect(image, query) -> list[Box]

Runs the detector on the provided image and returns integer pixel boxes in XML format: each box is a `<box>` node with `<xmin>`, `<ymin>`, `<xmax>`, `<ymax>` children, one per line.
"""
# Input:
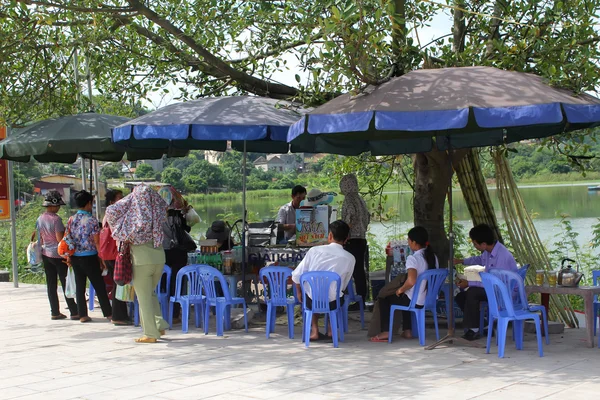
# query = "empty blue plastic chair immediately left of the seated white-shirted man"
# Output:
<box><xmin>259</xmin><ymin>267</ymin><xmax>300</xmax><ymax>339</ymax></box>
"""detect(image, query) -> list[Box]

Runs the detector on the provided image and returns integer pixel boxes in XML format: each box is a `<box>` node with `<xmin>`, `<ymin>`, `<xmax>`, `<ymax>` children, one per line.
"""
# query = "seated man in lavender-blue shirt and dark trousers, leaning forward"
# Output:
<box><xmin>454</xmin><ymin>224</ymin><xmax>517</xmax><ymax>340</ymax></box>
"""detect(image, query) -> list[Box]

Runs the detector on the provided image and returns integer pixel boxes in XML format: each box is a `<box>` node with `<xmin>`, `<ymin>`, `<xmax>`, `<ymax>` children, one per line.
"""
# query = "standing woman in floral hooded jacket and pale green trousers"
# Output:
<box><xmin>106</xmin><ymin>184</ymin><xmax>169</xmax><ymax>343</ymax></box>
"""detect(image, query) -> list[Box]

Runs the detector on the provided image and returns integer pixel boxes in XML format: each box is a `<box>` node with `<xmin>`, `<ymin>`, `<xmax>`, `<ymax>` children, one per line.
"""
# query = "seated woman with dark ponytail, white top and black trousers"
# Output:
<box><xmin>370</xmin><ymin>226</ymin><xmax>439</xmax><ymax>342</ymax></box>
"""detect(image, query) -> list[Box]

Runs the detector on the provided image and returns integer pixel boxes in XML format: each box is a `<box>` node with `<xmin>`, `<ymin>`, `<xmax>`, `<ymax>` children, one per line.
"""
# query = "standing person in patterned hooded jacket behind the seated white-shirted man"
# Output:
<box><xmin>340</xmin><ymin>174</ymin><xmax>371</xmax><ymax>310</ymax></box>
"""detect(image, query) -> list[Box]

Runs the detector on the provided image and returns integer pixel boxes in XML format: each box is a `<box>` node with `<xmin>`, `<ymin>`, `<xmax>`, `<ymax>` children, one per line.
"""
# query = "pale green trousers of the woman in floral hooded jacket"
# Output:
<box><xmin>131</xmin><ymin>245</ymin><xmax>169</xmax><ymax>339</ymax></box>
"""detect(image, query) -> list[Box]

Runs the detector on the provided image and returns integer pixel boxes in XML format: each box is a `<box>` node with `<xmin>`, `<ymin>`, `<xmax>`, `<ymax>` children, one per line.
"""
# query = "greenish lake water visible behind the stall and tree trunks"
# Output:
<box><xmin>193</xmin><ymin>185</ymin><xmax>600</xmax><ymax>250</ymax></box>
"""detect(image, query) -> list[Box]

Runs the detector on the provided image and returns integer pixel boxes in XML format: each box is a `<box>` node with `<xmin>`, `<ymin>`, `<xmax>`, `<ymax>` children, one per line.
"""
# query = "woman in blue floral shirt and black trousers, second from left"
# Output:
<box><xmin>67</xmin><ymin>190</ymin><xmax>112</xmax><ymax>322</ymax></box>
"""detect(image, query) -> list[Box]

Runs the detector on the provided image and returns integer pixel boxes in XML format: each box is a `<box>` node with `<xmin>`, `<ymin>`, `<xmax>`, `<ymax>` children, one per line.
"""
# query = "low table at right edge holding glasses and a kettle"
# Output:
<box><xmin>525</xmin><ymin>270</ymin><xmax>600</xmax><ymax>347</ymax></box>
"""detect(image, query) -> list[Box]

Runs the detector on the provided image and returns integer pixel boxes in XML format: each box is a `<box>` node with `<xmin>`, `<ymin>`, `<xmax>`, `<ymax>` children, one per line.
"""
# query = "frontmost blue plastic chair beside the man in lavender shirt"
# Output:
<box><xmin>480</xmin><ymin>271</ymin><xmax>544</xmax><ymax>358</ymax></box>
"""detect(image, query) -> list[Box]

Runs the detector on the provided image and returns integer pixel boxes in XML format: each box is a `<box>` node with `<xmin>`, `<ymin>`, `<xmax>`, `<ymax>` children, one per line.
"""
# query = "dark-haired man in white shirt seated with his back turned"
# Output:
<box><xmin>292</xmin><ymin>220</ymin><xmax>356</xmax><ymax>340</ymax></box>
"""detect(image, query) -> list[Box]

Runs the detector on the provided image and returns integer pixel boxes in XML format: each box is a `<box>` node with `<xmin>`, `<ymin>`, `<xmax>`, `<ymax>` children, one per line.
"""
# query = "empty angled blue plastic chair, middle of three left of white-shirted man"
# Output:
<box><xmin>193</xmin><ymin>264</ymin><xmax>248</xmax><ymax>336</ymax></box>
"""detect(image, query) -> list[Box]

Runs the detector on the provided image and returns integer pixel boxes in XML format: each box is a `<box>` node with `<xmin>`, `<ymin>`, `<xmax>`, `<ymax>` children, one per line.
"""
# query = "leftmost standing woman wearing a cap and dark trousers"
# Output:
<box><xmin>35</xmin><ymin>190</ymin><xmax>79</xmax><ymax>320</ymax></box>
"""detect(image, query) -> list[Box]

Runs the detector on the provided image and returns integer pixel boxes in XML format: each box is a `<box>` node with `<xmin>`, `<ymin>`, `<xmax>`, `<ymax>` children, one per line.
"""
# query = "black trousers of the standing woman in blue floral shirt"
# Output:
<box><xmin>71</xmin><ymin>255</ymin><xmax>112</xmax><ymax>318</ymax></box>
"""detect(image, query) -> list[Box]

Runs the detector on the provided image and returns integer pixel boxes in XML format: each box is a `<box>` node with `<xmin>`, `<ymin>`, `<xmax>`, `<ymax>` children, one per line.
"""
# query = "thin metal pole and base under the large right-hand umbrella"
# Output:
<box><xmin>425</xmin><ymin>137</ymin><xmax>484</xmax><ymax>350</ymax></box>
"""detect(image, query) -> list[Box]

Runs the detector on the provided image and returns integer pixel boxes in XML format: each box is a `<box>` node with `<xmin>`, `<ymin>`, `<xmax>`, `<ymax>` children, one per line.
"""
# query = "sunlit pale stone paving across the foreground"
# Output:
<box><xmin>0</xmin><ymin>283</ymin><xmax>600</xmax><ymax>400</ymax></box>
